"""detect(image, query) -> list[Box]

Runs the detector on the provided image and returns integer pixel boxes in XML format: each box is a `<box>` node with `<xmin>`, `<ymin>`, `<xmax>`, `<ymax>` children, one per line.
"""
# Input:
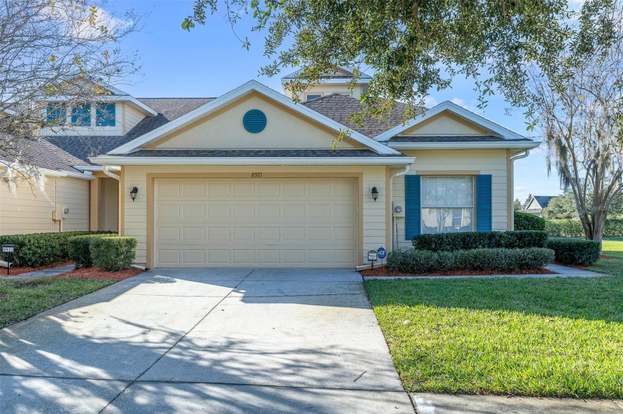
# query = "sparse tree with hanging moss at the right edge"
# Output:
<box><xmin>527</xmin><ymin>1</ymin><xmax>623</xmax><ymax>242</ymax></box>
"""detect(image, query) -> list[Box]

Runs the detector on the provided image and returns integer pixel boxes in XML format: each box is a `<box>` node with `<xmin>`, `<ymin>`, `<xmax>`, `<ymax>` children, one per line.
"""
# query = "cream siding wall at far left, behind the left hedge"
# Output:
<box><xmin>0</xmin><ymin>173</ymin><xmax>89</xmax><ymax>234</ymax></box>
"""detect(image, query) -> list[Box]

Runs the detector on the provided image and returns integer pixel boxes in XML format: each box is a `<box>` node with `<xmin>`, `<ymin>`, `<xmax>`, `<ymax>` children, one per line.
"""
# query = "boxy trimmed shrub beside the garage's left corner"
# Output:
<box><xmin>90</xmin><ymin>236</ymin><xmax>136</xmax><ymax>272</ymax></box>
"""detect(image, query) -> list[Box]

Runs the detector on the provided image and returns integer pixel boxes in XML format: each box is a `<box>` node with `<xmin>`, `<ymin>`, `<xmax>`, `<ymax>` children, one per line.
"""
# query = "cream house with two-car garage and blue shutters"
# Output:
<box><xmin>0</xmin><ymin>71</ymin><xmax>538</xmax><ymax>267</ymax></box>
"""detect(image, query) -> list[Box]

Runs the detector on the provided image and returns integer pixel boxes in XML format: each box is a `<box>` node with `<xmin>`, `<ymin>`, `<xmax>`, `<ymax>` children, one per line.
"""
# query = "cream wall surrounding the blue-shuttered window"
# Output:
<box><xmin>392</xmin><ymin>150</ymin><xmax>513</xmax><ymax>248</ymax></box>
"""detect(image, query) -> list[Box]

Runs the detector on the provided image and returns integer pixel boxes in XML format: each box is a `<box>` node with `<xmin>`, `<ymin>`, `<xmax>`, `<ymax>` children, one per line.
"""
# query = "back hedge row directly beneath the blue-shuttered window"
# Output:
<box><xmin>413</xmin><ymin>230</ymin><xmax>547</xmax><ymax>252</ymax></box>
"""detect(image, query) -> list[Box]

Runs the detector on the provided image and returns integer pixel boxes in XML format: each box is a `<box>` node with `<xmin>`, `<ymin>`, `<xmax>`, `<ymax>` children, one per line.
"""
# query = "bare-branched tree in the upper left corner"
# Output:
<box><xmin>0</xmin><ymin>0</ymin><xmax>136</xmax><ymax>170</ymax></box>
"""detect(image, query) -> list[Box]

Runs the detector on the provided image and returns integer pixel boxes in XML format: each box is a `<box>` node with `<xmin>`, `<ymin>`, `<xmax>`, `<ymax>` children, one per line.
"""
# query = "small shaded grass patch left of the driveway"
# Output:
<box><xmin>0</xmin><ymin>279</ymin><xmax>115</xmax><ymax>328</ymax></box>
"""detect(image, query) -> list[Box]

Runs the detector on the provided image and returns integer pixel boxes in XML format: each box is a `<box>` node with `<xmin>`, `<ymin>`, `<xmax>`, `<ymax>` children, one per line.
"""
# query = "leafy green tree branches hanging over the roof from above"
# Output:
<box><xmin>182</xmin><ymin>0</ymin><xmax>570</xmax><ymax>113</ymax></box>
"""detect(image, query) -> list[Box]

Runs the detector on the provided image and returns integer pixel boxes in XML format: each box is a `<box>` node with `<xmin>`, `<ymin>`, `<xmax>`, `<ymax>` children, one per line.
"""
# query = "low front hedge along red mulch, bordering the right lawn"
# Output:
<box><xmin>387</xmin><ymin>247</ymin><xmax>554</xmax><ymax>274</ymax></box>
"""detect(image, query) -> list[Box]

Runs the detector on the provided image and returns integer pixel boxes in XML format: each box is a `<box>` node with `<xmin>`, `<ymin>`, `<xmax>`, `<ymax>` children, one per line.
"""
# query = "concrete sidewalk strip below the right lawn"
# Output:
<box><xmin>410</xmin><ymin>393</ymin><xmax>623</xmax><ymax>414</ymax></box>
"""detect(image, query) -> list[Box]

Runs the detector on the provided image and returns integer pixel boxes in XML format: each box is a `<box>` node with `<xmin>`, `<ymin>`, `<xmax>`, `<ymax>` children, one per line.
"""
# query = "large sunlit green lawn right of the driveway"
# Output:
<box><xmin>366</xmin><ymin>241</ymin><xmax>623</xmax><ymax>398</ymax></box>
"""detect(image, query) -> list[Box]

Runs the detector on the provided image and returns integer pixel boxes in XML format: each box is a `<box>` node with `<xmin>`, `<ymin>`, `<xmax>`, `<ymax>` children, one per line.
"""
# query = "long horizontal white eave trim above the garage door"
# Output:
<box><xmin>90</xmin><ymin>155</ymin><xmax>415</xmax><ymax>165</ymax></box>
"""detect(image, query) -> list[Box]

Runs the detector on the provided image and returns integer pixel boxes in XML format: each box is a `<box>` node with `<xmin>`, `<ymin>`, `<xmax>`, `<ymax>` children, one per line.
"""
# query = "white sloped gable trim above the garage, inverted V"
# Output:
<box><xmin>108</xmin><ymin>80</ymin><xmax>400</xmax><ymax>155</ymax></box>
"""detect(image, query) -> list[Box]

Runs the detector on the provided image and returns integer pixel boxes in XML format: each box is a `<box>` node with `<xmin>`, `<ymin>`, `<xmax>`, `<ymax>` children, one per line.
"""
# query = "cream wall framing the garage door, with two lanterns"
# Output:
<box><xmin>120</xmin><ymin>165</ymin><xmax>389</xmax><ymax>265</ymax></box>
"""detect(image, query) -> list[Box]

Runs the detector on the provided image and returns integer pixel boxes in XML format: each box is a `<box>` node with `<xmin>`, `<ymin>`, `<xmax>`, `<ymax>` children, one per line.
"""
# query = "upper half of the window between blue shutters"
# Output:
<box><xmin>422</xmin><ymin>177</ymin><xmax>474</xmax><ymax>207</ymax></box>
